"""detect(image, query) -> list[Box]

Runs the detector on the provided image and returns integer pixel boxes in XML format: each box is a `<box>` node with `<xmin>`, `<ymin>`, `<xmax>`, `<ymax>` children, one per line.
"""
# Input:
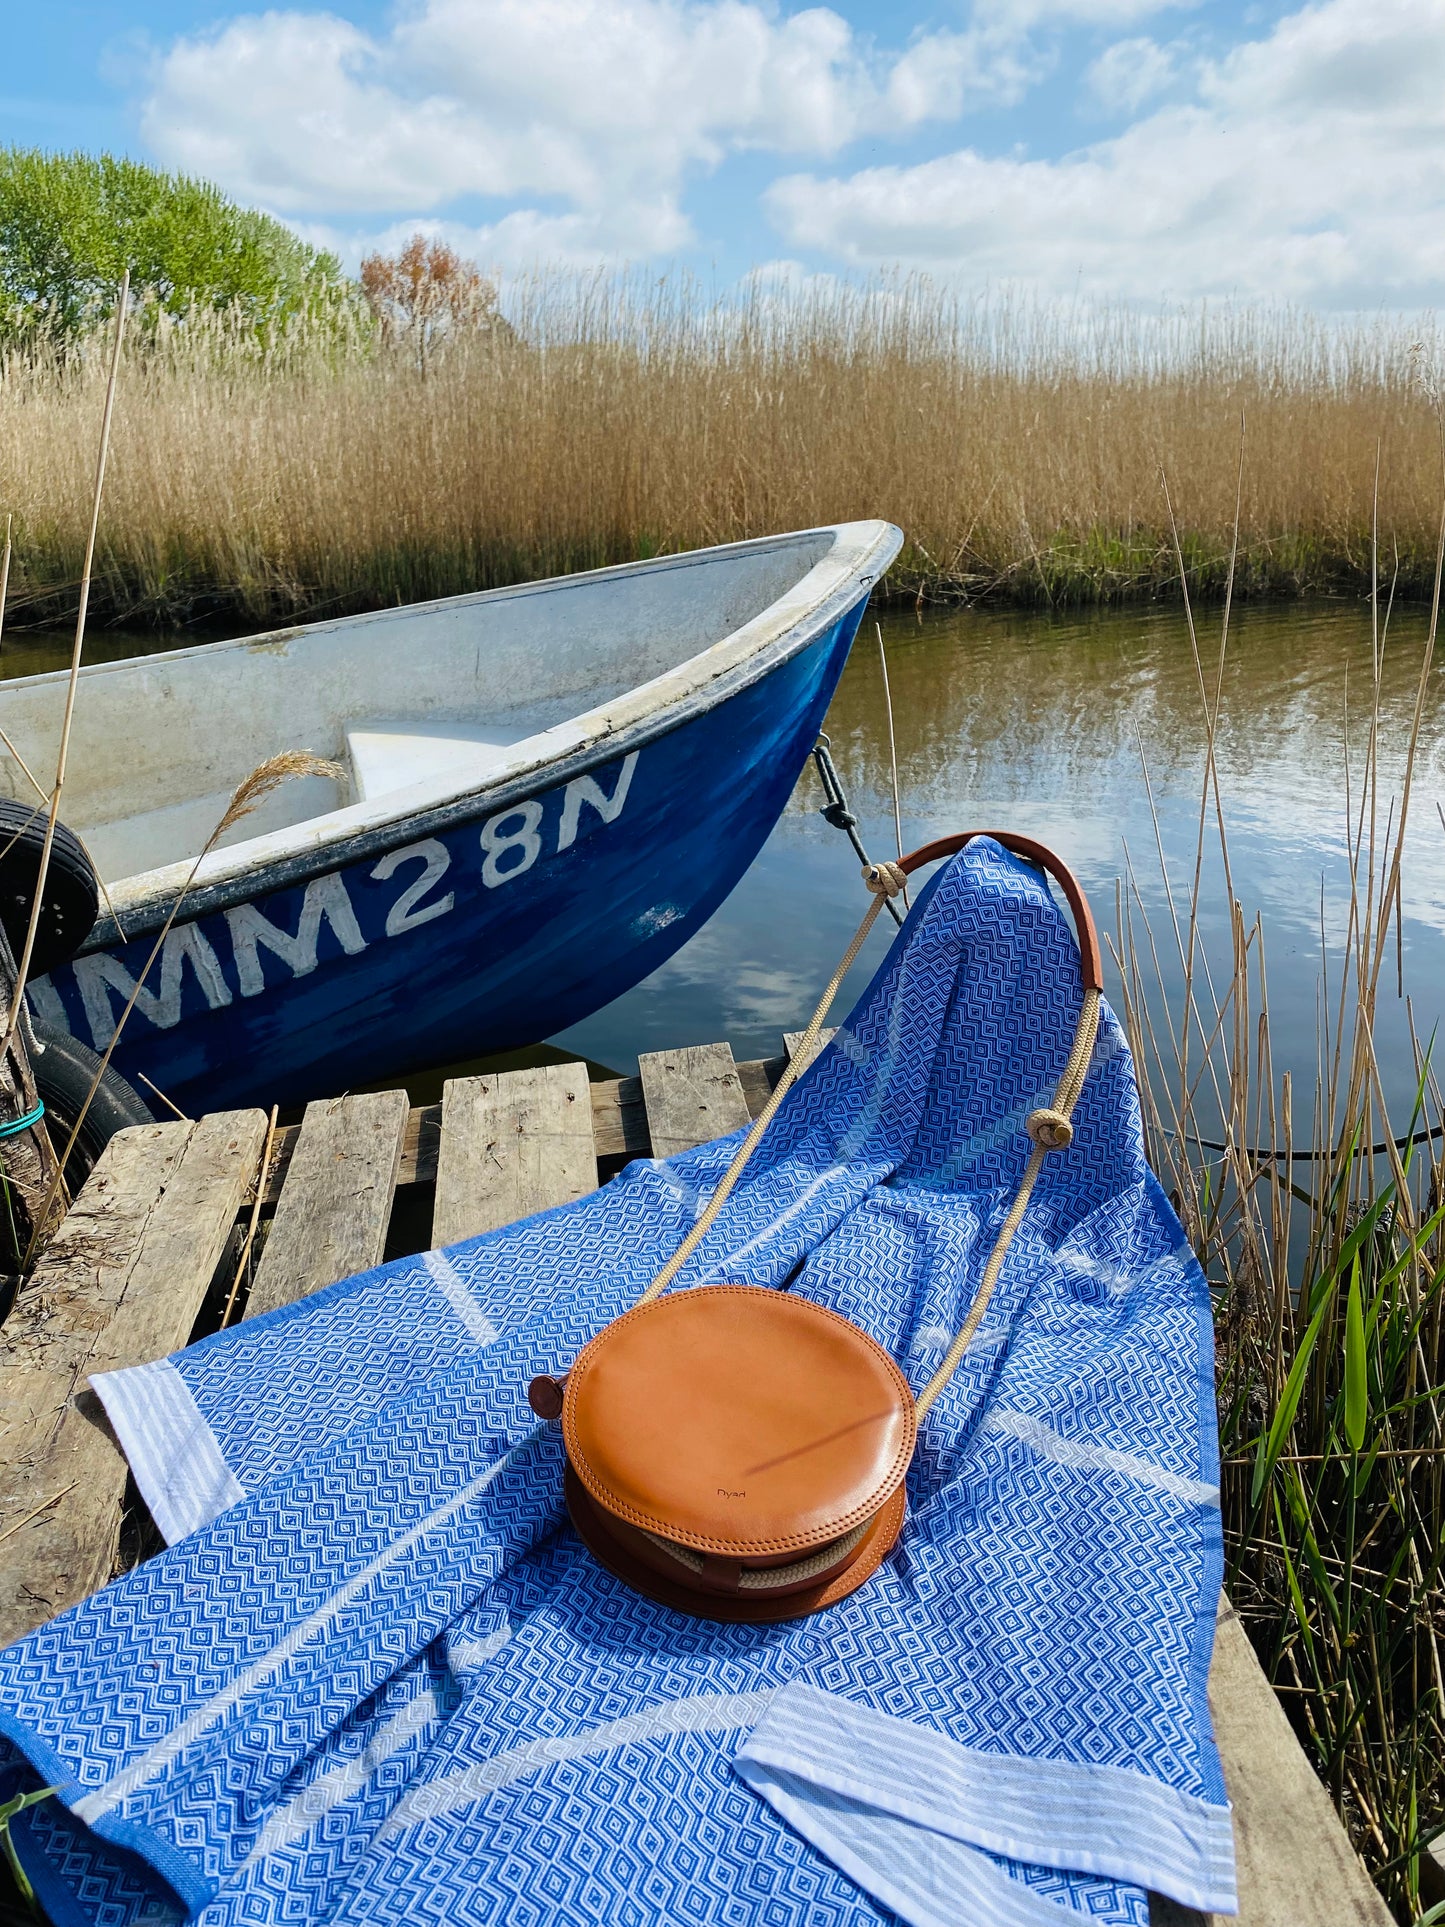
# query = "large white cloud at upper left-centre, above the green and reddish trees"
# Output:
<box><xmin>141</xmin><ymin>0</ymin><xmax>1202</xmax><ymax>260</ymax></box>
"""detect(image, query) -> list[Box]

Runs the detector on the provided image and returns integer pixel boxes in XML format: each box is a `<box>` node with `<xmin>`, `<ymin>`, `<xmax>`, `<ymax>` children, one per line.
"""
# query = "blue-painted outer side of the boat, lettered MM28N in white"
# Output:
<box><xmin>31</xmin><ymin>588</ymin><xmax>867</xmax><ymax>1116</ymax></box>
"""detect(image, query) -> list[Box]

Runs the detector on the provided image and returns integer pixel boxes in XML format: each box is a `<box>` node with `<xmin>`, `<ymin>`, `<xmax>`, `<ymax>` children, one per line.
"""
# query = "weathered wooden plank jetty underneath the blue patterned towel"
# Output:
<box><xmin>0</xmin><ymin>1035</ymin><xmax>1389</xmax><ymax>1927</ymax></box>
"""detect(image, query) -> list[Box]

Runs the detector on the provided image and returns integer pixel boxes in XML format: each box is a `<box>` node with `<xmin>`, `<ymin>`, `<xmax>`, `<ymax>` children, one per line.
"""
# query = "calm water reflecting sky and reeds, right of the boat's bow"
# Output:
<box><xmin>559</xmin><ymin>603</ymin><xmax>1445</xmax><ymax>1137</ymax></box>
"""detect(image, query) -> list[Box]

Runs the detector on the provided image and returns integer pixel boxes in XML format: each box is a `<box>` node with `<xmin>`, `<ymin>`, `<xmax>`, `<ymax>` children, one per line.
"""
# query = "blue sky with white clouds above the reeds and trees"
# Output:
<box><xmin>0</xmin><ymin>0</ymin><xmax>1445</xmax><ymax>312</ymax></box>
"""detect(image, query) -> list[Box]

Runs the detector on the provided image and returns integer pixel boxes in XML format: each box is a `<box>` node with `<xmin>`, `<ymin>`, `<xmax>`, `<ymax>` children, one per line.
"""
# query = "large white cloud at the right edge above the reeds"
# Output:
<box><xmin>767</xmin><ymin>0</ymin><xmax>1445</xmax><ymax>308</ymax></box>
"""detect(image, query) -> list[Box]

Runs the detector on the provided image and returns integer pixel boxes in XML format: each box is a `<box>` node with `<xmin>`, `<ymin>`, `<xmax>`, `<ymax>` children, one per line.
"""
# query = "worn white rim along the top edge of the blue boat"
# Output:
<box><xmin>70</xmin><ymin>520</ymin><xmax>902</xmax><ymax>956</ymax></box>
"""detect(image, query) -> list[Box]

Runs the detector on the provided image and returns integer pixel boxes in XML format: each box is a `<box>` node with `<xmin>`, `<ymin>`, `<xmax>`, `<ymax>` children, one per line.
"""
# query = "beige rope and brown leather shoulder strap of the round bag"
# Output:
<box><xmin>534</xmin><ymin>831</ymin><xmax>1104</xmax><ymax>1422</ymax></box>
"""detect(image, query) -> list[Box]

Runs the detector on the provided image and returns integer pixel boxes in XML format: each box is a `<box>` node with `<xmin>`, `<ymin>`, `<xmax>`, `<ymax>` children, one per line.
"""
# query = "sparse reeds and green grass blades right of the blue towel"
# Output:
<box><xmin>1114</xmin><ymin>539</ymin><xmax>1445</xmax><ymax>1923</ymax></box>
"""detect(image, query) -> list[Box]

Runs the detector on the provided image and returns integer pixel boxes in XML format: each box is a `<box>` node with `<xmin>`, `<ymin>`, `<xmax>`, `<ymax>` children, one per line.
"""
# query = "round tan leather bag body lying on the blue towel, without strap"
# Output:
<box><xmin>561</xmin><ymin>1285</ymin><xmax>917</xmax><ymax>1621</ymax></box>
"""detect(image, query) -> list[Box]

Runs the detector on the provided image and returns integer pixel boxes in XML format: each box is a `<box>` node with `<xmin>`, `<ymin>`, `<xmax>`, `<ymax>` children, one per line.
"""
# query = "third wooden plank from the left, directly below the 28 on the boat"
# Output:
<box><xmin>432</xmin><ymin>1064</ymin><xmax>597</xmax><ymax>1245</ymax></box>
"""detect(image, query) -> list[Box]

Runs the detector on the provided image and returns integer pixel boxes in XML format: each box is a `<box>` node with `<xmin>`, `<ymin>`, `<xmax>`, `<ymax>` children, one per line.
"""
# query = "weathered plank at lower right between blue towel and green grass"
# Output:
<box><xmin>1150</xmin><ymin>1599</ymin><xmax>1391</xmax><ymax>1927</ymax></box>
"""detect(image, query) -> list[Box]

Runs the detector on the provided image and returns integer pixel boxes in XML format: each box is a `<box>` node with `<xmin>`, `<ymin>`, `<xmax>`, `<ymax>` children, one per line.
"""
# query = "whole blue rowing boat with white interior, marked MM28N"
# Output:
<box><xmin>0</xmin><ymin>522</ymin><xmax>902</xmax><ymax>1114</ymax></box>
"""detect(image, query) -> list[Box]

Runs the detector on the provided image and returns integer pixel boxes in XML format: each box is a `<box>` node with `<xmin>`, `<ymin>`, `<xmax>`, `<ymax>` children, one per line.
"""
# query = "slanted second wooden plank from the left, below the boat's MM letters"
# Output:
<box><xmin>247</xmin><ymin>1091</ymin><xmax>408</xmax><ymax>1318</ymax></box>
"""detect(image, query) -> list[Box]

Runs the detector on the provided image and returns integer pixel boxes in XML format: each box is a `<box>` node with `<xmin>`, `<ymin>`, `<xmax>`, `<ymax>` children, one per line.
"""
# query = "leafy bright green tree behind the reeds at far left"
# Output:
<box><xmin>0</xmin><ymin>148</ymin><xmax>343</xmax><ymax>345</ymax></box>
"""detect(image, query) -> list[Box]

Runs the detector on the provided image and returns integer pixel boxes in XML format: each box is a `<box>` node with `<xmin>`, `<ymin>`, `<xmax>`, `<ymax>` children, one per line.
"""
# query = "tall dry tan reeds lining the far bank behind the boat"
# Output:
<box><xmin>0</xmin><ymin>279</ymin><xmax>1439</xmax><ymax>622</ymax></box>
